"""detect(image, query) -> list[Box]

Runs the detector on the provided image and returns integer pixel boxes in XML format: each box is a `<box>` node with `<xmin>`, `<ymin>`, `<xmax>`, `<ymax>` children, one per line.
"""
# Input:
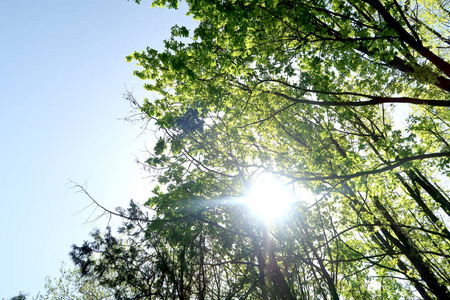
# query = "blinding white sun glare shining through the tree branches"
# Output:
<box><xmin>244</xmin><ymin>174</ymin><xmax>297</xmax><ymax>223</ymax></box>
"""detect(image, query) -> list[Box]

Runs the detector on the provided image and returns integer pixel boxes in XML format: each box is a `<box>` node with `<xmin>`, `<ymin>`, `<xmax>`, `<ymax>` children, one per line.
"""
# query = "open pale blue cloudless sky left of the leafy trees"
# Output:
<box><xmin>0</xmin><ymin>0</ymin><xmax>192</xmax><ymax>299</ymax></box>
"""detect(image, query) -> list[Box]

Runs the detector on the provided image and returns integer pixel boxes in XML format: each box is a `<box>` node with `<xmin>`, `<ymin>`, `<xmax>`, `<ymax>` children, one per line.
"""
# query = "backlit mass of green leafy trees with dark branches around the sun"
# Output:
<box><xmin>72</xmin><ymin>0</ymin><xmax>450</xmax><ymax>299</ymax></box>
